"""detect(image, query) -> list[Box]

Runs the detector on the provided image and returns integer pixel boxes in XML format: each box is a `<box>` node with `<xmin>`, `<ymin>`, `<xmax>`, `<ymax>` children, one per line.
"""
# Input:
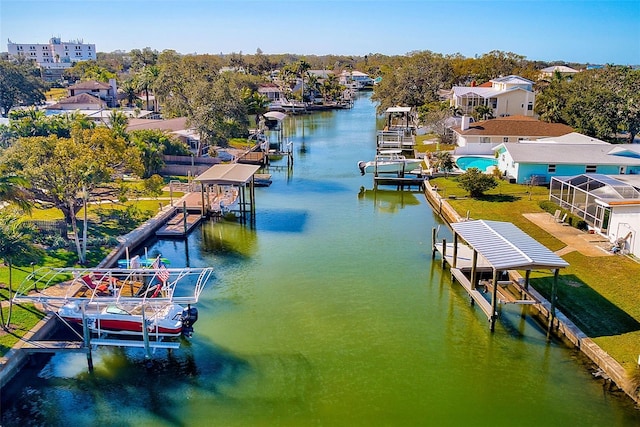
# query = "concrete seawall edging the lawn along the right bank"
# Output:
<box><xmin>424</xmin><ymin>181</ymin><xmax>640</xmax><ymax>404</ymax></box>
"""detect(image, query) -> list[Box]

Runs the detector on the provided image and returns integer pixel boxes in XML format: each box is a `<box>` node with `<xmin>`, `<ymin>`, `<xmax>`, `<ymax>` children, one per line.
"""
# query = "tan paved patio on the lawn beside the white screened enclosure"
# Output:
<box><xmin>522</xmin><ymin>212</ymin><xmax>613</xmax><ymax>257</ymax></box>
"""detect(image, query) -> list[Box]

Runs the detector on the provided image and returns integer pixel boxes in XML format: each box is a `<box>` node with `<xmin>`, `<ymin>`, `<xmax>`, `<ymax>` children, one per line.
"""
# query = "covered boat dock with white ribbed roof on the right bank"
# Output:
<box><xmin>432</xmin><ymin>220</ymin><xmax>569</xmax><ymax>331</ymax></box>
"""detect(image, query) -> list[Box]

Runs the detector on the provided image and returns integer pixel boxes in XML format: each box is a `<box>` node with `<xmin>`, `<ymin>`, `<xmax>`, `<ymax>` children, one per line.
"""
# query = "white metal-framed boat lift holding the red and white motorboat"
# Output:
<box><xmin>12</xmin><ymin>267</ymin><xmax>213</xmax><ymax>370</ymax></box>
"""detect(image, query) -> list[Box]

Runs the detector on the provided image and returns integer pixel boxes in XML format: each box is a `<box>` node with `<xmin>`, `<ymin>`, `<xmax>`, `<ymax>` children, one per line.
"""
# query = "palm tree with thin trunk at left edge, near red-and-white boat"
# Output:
<box><xmin>0</xmin><ymin>215</ymin><xmax>42</xmax><ymax>331</ymax></box>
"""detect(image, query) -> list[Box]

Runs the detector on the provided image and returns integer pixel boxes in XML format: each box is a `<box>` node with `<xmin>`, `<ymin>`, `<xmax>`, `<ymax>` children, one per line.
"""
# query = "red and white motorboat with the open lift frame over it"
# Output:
<box><xmin>14</xmin><ymin>262</ymin><xmax>213</xmax><ymax>351</ymax></box>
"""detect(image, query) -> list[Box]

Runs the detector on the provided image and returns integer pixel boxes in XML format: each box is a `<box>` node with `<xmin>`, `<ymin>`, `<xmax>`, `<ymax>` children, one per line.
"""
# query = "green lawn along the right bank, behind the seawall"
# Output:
<box><xmin>431</xmin><ymin>178</ymin><xmax>640</xmax><ymax>372</ymax></box>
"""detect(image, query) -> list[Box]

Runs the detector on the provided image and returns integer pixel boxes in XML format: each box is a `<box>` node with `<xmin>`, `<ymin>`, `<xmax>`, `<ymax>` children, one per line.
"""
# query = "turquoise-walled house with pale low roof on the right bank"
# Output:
<box><xmin>494</xmin><ymin>137</ymin><xmax>640</xmax><ymax>184</ymax></box>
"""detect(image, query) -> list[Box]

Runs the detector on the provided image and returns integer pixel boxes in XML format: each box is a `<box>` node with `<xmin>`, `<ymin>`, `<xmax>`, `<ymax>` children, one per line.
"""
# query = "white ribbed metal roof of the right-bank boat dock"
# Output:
<box><xmin>451</xmin><ymin>220</ymin><xmax>569</xmax><ymax>270</ymax></box>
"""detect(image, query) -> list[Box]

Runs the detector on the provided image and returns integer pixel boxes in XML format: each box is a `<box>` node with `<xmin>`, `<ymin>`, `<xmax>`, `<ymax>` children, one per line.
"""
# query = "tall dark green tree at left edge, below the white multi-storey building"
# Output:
<box><xmin>0</xmin><ymin>60</ymin><xmax>46</xmax><ymax>117</ymax></box>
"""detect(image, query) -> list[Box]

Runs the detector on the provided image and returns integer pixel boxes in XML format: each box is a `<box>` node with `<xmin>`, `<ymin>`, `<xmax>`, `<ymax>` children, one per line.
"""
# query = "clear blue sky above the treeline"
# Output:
<box><xmin>0</xmin><ymin>0</ymin><xmax>640</xmax><ymax>65</ymax></box>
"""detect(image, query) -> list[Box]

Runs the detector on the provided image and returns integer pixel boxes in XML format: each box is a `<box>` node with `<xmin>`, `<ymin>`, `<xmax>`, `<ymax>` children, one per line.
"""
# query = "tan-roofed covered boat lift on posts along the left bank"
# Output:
<box><xmin>194</xmin><ymin>163</ymin><xmax>260</xmax><ymax>224</ymax></box>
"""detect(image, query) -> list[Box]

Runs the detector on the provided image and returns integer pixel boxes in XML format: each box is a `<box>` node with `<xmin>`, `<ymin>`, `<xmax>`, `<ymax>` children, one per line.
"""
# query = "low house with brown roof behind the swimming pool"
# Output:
<box><xmin>451</xmin><ymin>116</ymin><xmax>573</xmax><ymax>147</ymax></box>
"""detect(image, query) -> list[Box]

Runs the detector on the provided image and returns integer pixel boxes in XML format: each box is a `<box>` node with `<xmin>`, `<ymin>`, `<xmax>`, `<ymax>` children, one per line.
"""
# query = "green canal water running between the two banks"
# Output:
<box><xmin>2</xmin><ymin>94</ymin><xmax>640</xmax><ymax>426</ymax></box>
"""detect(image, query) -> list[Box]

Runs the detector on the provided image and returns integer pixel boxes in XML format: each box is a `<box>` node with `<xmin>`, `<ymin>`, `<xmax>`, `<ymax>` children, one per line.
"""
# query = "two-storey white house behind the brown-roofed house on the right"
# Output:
<box><xmin>448</xmin><ymin>75</ymin><xmax>536</xmax><ymax>117</ymax></box>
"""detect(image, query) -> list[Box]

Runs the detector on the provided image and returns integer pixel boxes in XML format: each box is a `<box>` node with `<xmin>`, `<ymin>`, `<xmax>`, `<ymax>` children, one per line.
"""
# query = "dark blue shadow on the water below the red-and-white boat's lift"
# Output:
<box><xmin>2</xmin><ymin>340</ymin><xmax>251</xmax><ymax>426</ymax></box>
